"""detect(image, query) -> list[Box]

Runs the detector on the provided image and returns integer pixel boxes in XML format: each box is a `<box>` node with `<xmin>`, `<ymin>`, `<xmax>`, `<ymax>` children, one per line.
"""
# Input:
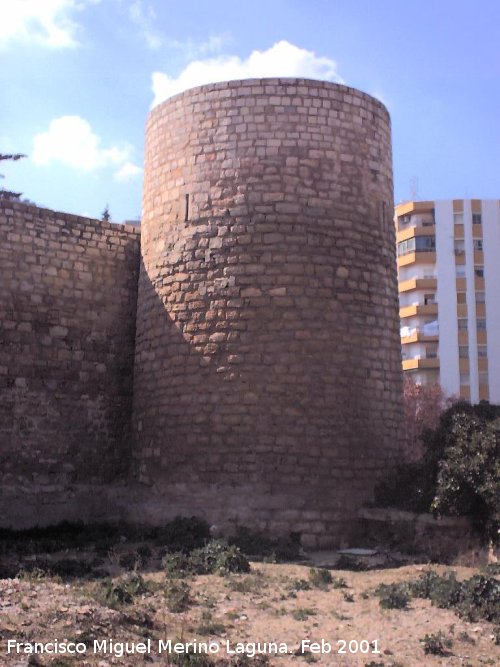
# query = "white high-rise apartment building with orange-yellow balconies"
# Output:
<box><xmin>395</xmin><ymin>199</ymin><xmax>500</xmax><ymax>403</ymax></box>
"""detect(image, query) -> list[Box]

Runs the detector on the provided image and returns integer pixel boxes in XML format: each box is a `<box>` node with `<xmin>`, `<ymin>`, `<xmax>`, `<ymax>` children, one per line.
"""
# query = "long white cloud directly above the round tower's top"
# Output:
<box><xmin>152</xmin><ymin>40</ymin><xmax>342</xmax><ymax>106</ymax></box>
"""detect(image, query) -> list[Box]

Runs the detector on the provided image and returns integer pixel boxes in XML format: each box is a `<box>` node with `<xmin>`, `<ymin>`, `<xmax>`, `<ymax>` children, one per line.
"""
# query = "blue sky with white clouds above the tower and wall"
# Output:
<box><xmin>0</xmin><ymin>0</ymin><xmax>500</xmax><ymax>222</ymax></box>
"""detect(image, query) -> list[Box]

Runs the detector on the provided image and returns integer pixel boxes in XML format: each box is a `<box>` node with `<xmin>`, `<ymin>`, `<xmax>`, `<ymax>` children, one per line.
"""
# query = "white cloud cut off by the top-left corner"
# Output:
<box><xmin>0</xmin><ymin>0</ymin><xmax>99</xmax><ymax>48</ymax></box>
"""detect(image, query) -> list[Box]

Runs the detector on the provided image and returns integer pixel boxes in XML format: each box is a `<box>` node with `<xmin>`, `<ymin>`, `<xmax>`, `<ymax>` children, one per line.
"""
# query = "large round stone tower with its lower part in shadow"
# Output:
<box><xmin>134</xmin><ymin>79</ymin><xmax>402</xmax><ymax>546</ymax></box>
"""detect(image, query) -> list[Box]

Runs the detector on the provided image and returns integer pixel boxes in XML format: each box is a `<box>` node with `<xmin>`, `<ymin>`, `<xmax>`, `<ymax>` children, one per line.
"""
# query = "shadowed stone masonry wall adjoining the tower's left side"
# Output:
<box><xmin>0</xmin><ymin>201</ymin><xmax>139</xmax><ymax>527</ymax></box>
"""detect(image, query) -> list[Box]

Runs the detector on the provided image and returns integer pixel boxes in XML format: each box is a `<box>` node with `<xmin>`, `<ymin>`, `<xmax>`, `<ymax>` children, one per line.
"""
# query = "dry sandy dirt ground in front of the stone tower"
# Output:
<box><xmin>0</xmin><ymin>552</ymin><xmax>500</xmax><ymax>667</ymax></box>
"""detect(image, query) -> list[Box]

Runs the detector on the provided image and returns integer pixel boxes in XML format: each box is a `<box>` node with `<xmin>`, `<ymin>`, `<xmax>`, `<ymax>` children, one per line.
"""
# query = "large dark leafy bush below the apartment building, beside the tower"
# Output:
<box><xmin>375</xmin><ymin>401</ymin><xmax>500</xmax><ymax>542</ymax></box>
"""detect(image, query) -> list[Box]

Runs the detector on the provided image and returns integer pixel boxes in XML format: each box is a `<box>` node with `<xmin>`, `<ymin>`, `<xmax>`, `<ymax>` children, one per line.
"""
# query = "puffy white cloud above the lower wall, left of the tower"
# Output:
<box><xmin>31</xmin><ymin>116</ymin><xmax>141</xmax><ymax>180</ymax></box>
